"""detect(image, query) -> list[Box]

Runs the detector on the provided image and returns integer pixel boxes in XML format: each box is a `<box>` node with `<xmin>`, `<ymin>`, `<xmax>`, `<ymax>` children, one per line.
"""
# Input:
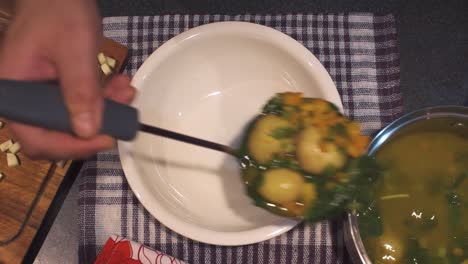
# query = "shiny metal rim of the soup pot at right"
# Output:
<box><xmin>343</xmin><ymin>105</ymin><xmax>468</xmax><ymax>264</ymax></box>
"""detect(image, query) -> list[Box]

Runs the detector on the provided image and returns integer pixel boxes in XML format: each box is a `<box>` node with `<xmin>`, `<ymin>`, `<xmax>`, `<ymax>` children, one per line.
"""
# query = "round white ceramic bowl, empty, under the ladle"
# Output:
<box><xmin>119</xmin><ymin>22</ymin><xmax>342</xmax><ymax>245</ymax></box>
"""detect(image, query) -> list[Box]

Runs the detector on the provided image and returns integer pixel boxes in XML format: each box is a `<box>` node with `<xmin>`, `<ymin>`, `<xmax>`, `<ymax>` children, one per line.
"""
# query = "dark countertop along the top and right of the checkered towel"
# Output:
<box><xmin>98</xmin><ymin>0</ymin><xmax>468</xmax><ymax>112</ymax></box>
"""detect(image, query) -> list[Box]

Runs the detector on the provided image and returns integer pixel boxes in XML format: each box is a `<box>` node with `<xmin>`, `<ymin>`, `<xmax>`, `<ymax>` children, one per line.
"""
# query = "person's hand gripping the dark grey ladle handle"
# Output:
<box><xmin>0</xmin><ymin>0</ymin><xmax>135</xmax><ymax>159</ymax></box>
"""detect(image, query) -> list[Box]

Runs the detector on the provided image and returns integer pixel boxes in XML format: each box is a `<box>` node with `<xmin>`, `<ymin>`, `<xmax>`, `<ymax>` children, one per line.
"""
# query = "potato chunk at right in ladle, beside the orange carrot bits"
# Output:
<box><xmin>297</xmin><ymin>127</ymin><xmax>346</xmax><ymax>174</ymax></box>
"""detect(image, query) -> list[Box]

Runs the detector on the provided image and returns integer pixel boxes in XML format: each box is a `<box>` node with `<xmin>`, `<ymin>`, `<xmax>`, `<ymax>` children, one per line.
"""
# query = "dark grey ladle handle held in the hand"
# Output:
<box><xmin>0</xmin><ymin>80</ymin><xmax>139</xmax><ymax>140</ymax></box>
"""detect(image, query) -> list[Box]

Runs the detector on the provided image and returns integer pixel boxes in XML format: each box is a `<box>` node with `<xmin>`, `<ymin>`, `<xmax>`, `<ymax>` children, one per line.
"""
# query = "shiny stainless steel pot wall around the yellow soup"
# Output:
<box><xmin>343</xmin><ymin>106</ymin><xmax>468</xmax><ymax>264</ymax></box>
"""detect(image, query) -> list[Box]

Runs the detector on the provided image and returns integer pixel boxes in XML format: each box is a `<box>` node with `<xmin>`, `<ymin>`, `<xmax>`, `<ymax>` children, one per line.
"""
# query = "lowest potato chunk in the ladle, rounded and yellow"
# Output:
<box><xmin>258</xmin><ymin>168</ymin><xmax>304</xmax><ymax>204</ymax></box>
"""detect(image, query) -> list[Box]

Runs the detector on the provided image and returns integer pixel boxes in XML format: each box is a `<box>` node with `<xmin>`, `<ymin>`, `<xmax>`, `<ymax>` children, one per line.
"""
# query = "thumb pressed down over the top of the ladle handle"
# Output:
<box><xmin>56</xmin><ymin>36</ymin><xmax>103</xmax><ymax>138</ymax></box>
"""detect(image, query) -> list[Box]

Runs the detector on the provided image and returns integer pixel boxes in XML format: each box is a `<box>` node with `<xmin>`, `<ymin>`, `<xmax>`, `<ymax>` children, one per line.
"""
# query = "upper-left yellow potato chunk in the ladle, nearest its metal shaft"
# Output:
<box><xmin>248</xmin><ymin>115</ymin><xmax>292</xmax><ymax>164</ymax></box>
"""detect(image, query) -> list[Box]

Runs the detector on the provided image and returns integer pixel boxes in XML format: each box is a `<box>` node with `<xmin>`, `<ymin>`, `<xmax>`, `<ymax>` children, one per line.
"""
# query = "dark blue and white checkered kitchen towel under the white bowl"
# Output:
<box><xmin>79</xmin><ymin>13</ymin><xmax>402</xmax><ymax>263</ymax></box>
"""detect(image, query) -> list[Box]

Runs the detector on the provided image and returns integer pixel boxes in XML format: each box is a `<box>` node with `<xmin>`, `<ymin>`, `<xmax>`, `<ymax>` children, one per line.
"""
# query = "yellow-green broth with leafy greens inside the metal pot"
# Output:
<box><xmin>358</xmin><ymin>119</ymin><xmax>468</xmax><ymax>263</ymax></box>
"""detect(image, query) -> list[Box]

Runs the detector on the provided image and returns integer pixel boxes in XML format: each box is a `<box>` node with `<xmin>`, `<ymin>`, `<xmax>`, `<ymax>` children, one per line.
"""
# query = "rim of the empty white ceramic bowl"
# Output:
<box><xmin>118</xmin><ymin>21</ymin><xmax>343</xmax><ymax>246</ymax></box>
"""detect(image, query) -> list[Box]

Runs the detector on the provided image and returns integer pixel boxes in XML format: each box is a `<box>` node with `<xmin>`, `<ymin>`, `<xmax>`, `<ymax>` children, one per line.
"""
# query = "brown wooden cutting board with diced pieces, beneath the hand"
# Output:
<box><xmin>0</xmin><ymin>6</ymin><xmax>128</xmax><ymax>264</ymax></box>
